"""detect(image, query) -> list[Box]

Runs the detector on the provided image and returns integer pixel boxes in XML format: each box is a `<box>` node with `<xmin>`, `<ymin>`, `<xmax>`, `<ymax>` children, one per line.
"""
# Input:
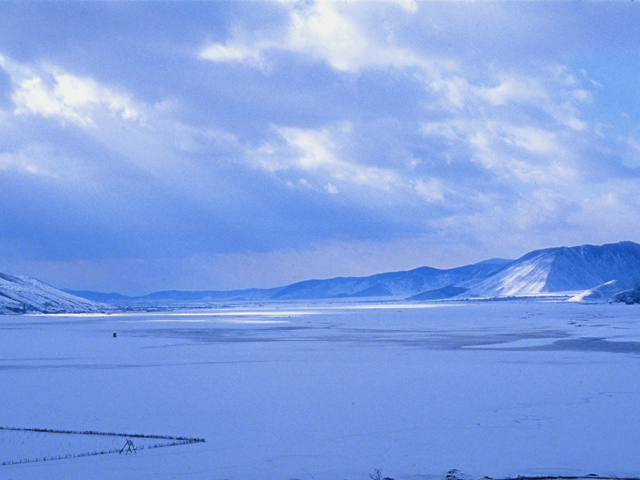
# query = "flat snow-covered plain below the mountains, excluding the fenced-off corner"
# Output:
<box><xmin>0</xmin><ymin>301</ymin><xmax>640</xmax><ymax>480</ymax></box>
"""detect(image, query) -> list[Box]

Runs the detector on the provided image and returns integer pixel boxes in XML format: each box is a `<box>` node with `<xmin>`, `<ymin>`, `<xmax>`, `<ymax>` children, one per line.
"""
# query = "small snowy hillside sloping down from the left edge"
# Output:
<box><xmin>0</xmin><ymin>273</ymin><xmax>110</xmax><ymax>313</ymax></box>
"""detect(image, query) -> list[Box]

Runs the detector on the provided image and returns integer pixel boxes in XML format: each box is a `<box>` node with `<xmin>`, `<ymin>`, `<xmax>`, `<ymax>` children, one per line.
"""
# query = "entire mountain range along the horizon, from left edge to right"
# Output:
<box><xmin>0</xmin><ymin>242</ymin><xmax>640</xmax><ymax>313</ymax></box>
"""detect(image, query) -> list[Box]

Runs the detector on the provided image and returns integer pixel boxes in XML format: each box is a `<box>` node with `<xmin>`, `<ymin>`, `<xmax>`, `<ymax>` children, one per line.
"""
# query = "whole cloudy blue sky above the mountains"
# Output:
<box><xmin>0</xmin><ymin>0</ymin><xmax>640</xmax><ymax>295</ymax></box>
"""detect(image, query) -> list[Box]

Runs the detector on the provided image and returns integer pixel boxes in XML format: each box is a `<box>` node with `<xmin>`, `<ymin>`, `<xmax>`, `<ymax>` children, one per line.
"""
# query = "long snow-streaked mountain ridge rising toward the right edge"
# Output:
<box><xmin>270</xmin><ymin>242</ymin><xmax>640</xmax><ymax>300</ymax></box>
